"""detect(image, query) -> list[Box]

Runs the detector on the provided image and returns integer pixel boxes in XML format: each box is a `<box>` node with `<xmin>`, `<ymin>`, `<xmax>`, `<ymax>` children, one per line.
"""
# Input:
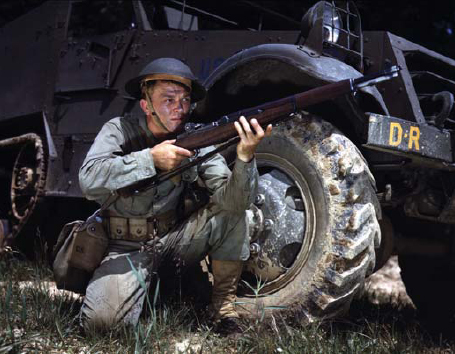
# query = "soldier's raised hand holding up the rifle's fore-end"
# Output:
<box><xmin>234</xmin><ymin>116</ymin><xmax>272</xmax><ymax>162</ymax></box>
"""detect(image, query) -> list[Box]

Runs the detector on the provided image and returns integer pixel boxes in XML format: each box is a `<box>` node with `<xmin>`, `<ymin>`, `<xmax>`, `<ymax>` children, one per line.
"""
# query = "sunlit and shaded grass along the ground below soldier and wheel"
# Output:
<box><xmin>0</xmin><ymin>248</ymin><xmax>455</xmax><ymax>353</ymax></box>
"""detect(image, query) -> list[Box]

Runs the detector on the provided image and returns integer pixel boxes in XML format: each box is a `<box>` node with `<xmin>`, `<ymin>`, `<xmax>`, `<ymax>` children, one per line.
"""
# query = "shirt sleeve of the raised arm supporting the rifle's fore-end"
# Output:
<box><xmin>198</xmin><ymin>147</ymin><xmax>259</xmax><ymax>211</ymax></box>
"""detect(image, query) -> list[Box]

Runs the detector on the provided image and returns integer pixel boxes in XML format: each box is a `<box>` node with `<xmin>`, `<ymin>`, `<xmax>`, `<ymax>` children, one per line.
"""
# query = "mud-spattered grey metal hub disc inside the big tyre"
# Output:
<box><xmin>244</xmin><ymin>169</ymin><xmax>305</xmax><ymax>282</ymax></box>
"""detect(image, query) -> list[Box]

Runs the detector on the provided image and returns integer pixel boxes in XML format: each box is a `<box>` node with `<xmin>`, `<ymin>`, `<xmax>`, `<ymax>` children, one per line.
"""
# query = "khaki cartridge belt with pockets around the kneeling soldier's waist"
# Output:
<box><xmin>101</xmin><ymin>210</ymin><xmax>177</xmax><ymax>241</ymax></box>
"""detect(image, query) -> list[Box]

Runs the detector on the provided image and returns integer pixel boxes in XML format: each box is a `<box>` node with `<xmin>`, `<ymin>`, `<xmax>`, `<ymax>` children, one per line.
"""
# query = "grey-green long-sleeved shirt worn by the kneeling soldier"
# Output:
<box><xmin>79</xmin><ymin>116</ymin><xmax>258</xmax><ymax>217</ymax></box>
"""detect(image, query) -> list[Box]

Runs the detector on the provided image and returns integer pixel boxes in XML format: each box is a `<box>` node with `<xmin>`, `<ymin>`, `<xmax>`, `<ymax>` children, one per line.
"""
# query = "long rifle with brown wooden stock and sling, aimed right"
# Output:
<box><xmin>116</xmin><ymin>66</ymin><xmax>401</xmax><ymax>197</ymax></box>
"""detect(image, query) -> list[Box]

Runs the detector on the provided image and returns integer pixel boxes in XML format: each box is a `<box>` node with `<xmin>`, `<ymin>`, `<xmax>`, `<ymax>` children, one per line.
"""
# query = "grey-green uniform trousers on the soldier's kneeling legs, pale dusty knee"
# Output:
<box><xmin>80</xmin><ymin>204</ymin><xmax>249</xmax><ymax>329</ymax></box>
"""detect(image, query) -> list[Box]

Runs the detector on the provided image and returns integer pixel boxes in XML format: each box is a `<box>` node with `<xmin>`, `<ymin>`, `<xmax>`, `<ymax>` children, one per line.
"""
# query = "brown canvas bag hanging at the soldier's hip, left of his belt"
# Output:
<box><xmin>53</xmin><ymin>212</ymin><xmax>108</xmax><ymax>294</ymax></box>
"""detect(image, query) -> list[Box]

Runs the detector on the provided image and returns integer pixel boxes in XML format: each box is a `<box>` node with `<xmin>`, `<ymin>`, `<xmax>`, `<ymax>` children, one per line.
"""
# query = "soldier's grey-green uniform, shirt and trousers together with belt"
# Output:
<box><xmin>79</xmin><ymin>117</ymin><xmax>258</xmax><ymax>327</ymax></box>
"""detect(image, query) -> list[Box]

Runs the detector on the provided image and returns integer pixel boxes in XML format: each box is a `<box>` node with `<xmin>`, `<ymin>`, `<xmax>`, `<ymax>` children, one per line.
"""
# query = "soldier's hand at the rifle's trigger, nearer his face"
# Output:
<box><xmin>150</xmin><ymin>139</ymin><xmax>194</xmax><ymax>171</ymax></box>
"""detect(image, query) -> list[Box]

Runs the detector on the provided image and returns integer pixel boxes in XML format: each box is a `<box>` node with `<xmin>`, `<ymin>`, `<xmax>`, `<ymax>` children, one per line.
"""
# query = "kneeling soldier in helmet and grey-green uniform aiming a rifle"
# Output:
<box><xmin>79</xmin><ymin>58</ymin><xmax>272</xmax><ymax>333</ymax></box>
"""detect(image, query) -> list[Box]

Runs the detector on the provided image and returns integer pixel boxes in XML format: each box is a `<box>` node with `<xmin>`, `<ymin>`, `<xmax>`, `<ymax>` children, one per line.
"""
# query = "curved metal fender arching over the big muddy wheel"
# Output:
<box><xmin>196</xmin><ymin>44</ymin><xmax>388</xmax><ymax>131</ymax></box>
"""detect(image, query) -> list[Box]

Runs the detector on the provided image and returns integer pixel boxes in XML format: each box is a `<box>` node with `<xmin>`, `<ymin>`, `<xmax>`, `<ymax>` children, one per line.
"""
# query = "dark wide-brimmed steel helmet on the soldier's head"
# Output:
<box><xmin>125</xmin><ymin>58</ymin><xmax>206</xmax><ymax>102</ymax></box>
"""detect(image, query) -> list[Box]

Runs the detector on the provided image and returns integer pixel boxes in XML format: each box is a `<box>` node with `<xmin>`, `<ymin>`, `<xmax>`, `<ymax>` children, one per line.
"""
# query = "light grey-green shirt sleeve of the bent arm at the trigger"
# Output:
<box><xmin>79</xmin><ymin>118</ymin><xmax>156</xmax><ymax>200</ymax></box>
